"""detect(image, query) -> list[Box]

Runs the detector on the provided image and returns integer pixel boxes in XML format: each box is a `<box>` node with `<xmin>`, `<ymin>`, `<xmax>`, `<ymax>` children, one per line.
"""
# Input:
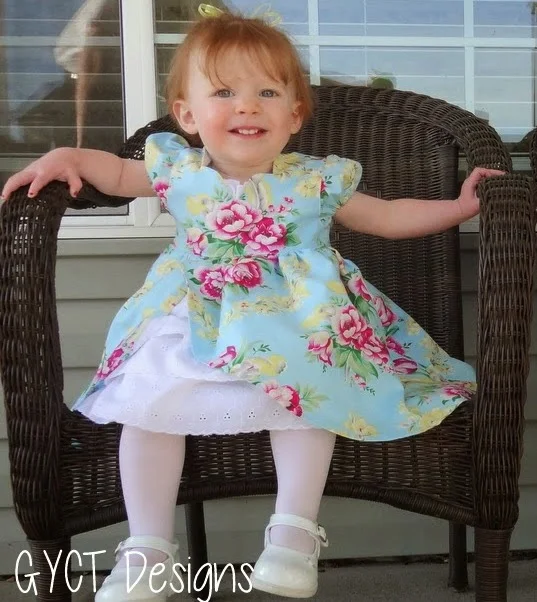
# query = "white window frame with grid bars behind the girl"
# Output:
<box><xmin>56</xmin><ymin>0</ymin><xmax>537</xmax><ymax>239</ymax></box>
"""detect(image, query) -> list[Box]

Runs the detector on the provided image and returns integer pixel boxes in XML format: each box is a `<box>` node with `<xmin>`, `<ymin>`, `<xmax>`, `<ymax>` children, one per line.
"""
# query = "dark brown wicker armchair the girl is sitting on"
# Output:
<box><xmin>0</xmin><ymin>86</ymin><xmax>535</xmax><ymax>602</ymax></box>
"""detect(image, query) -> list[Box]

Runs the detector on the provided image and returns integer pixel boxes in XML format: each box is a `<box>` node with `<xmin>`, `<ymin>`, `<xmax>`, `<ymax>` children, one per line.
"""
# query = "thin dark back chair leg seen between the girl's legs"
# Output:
<box><xmin>185</xmin><ymin>502</ymin><xmax>212</xmax><ymax>600</ymax></box>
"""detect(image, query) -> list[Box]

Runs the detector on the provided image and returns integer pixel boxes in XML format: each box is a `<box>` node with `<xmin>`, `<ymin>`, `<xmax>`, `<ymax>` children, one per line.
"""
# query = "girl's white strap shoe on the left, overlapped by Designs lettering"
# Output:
<box><xmin>95</xmin><ymin>535</ymin><xmax>179</xmax><ymax>602</ymax></box>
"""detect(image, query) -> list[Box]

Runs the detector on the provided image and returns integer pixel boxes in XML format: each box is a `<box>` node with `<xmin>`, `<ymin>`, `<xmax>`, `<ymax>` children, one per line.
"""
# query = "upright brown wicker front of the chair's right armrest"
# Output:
<box><xmin>473</xmin><ymin>174</ymin><xmax>536</xmax><ymax>529</ymax></box>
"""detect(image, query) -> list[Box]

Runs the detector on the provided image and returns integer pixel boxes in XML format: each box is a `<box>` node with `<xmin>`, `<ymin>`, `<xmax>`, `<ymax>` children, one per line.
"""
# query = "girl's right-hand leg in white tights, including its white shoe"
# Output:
<box><xmin>251</xmin><ymin>429</ymin><xmax>336</xmax><ymax>598</ymax></box>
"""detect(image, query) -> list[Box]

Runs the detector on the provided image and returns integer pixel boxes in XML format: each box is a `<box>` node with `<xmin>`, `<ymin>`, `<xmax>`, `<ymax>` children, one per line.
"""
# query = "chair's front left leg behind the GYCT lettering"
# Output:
<box><xmin>25</xmin><ymin>537</ymin><xmax>71</xmax><ymax>602</ymax></box>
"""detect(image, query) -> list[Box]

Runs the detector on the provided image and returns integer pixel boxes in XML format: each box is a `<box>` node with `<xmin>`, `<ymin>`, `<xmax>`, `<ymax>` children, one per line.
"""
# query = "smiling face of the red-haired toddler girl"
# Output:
<box><xmin>174</xmin><ymin>51</ymin><xmax>302</xmax><ymax>180</ymax></box>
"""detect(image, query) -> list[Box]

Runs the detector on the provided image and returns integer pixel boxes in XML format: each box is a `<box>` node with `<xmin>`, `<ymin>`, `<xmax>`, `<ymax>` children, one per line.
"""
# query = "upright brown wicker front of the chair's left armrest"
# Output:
<box><xmin>0</xmin><ymin>182</ymin><xmax>72</xmax><ymax>539</ymax></box>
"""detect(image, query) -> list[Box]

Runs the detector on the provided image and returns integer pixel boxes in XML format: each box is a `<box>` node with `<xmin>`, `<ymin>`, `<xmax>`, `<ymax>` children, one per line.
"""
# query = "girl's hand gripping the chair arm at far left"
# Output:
<box><xmin>2</xmin><ymin>148</ymin><xmax>82</xmax><ymax>200</ymax></box>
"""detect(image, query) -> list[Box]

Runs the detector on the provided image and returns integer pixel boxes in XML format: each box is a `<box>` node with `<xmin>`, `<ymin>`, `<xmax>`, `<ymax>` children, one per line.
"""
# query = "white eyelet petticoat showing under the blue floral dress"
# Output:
<box><xmin>77</xmin><ymin>297</ymin><xmax>311</xmax><ymax>435</ymax></box>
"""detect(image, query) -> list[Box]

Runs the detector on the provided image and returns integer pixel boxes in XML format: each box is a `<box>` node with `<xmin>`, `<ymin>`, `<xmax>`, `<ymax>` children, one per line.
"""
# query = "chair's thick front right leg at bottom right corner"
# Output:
<box><xmin>475</xmin><ymin>528</ymin><xmax>512</xmax><ymax>602</ymax></box>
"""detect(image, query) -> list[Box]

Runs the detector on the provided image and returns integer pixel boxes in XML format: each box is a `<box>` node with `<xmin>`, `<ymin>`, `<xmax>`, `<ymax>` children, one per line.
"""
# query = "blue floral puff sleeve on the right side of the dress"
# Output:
<box><xmin>321</xmin><ymin>155</ymin><xmax>362</xmax><ymax>217</ymax></box>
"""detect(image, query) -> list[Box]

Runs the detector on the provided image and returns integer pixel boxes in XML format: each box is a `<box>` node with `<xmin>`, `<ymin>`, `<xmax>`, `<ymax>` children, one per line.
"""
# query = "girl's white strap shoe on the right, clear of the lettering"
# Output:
<box><xmin>250</xmin><ymin>514</ymin><xmax>328</xmax><ymax>598</ymax></box>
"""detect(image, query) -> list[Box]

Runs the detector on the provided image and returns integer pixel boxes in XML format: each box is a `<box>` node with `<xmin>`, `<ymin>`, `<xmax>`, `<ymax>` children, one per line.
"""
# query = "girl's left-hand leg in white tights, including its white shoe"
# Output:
<box><xmin>95</xmin><ymin>427</ymin><xmax>185</xmax><ymax>602</ymax></box>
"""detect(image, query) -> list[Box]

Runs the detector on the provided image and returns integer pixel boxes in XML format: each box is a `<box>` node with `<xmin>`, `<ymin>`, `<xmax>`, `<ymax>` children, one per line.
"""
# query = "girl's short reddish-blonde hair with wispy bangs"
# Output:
<box><xmin>166</xmin><ymin>12</ymin><xmax>313</xmax><ymax>120</ymax></box>
